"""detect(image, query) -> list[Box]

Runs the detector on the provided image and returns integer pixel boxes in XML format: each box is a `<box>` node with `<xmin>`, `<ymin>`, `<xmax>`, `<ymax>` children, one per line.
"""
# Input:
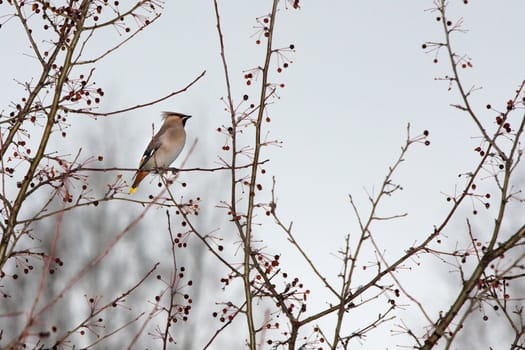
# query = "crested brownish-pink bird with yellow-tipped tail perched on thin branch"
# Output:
<box><xmin>129</xmin><ymin>112</ymin><xmax>191</xmax><ymax>194</ymax></box>
